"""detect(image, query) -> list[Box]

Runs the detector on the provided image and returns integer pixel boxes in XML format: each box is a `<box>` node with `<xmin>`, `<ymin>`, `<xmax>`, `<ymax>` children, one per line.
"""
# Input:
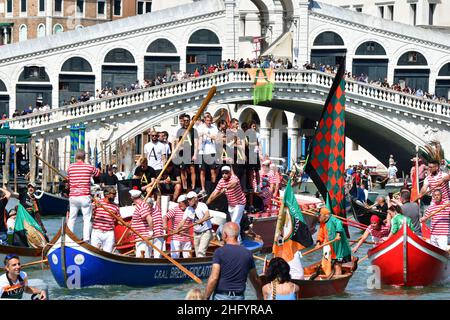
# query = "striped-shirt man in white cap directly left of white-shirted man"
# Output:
<box><xmin>163</xmin><ymin>194</ymin><xmax>192</xmax><ymax>259</ymax></box>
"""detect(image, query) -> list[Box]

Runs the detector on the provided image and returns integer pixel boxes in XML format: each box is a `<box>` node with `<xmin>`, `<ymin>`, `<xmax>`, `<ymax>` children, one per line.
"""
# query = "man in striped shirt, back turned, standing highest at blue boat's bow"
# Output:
<box><xmin>67</xmin><ymin>149</ymin><xmax>100</xmax><ymax>242</ymax></box>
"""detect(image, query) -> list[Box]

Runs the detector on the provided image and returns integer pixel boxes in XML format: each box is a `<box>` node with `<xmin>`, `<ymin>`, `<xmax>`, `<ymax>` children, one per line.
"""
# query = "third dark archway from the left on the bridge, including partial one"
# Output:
<box><xmin>59</xmin><ymin>57</ymin><xmax>95</xmax><ymax>106</ymax></box>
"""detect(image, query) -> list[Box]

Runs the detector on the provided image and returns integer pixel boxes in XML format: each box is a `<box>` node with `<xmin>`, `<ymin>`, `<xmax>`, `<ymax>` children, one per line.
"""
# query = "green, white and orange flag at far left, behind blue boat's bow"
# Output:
<box><xmin>13</xmin><ymin>203</ymin><xmax>47</xmax><ymax>248</ymax></box>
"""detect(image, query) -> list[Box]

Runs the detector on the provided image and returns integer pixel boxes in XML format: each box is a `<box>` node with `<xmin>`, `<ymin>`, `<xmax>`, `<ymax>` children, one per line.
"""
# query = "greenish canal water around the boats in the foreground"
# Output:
<box><xmin>22</xmin><ymin>212</ymin><xmax>450</xmax><ymax>300</ymax></box>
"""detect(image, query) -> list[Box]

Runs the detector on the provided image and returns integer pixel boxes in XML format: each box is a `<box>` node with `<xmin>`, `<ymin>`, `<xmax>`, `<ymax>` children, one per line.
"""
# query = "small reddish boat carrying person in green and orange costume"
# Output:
<box><xmin>260</xmin><ymin>262</ymin><xmax>353</xmax><ymax>299</ymax></box>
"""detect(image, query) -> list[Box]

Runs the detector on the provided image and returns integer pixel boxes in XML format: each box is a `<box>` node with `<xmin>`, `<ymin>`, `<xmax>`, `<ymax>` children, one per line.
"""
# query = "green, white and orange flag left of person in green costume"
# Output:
<box><xmin>272</xmin><ymin>179</ymin><xmax>314</xmax><ymax>261</ymax></box>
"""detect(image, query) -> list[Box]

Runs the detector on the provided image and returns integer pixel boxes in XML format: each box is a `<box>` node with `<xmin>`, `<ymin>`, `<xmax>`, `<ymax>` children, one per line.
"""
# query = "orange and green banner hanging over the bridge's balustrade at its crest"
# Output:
<box><xmin>247</xmin><ymin>68</ymin><xmax>275</xmax><ymax>105</ymax></box>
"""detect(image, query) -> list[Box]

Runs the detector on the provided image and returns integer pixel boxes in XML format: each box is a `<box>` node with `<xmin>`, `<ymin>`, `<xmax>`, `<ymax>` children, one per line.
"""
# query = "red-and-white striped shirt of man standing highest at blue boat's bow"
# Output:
<box><xmin>67</xmin><ymin>161</ymin><xmax>100</xmax><ymax>197</ymax></box>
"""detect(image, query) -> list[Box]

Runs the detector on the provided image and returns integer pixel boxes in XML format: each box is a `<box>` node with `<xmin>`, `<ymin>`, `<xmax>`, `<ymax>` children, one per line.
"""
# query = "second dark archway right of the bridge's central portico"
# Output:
<box><xmin>352</xmin><ymin>41</ymin><xmax>389</xmax><ymax>82</ymax></box>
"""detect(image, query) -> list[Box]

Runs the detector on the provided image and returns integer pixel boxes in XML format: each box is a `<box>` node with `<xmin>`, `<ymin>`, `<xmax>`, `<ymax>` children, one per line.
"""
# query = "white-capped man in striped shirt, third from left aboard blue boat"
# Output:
<box><xmin>129</xmin><ymin>189</ymin><xmax>153</xmax><ymax>258</ymax></box>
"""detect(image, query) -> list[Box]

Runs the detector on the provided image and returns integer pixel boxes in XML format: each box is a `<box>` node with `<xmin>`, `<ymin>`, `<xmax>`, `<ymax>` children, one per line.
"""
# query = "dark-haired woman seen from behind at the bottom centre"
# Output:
<box><xmin>262</xmin><ymin>257</ymin><xmax>299</xmax><ymax>300</ymax></box>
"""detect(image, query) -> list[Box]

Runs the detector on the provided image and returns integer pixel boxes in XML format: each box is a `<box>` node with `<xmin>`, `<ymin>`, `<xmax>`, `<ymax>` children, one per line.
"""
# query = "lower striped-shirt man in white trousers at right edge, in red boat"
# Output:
<box><xmin>420</xmin><ymin>189</ymin><xmax>450</xmax><ymax>250</ymax></box>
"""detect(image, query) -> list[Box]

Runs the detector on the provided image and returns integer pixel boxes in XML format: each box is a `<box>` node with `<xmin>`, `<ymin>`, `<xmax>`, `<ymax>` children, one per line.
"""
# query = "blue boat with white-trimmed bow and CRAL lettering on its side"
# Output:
<box><xmin>46</xmin><ymin>227</ymin><xmax>263</xmax><ymax>289</ymax></box>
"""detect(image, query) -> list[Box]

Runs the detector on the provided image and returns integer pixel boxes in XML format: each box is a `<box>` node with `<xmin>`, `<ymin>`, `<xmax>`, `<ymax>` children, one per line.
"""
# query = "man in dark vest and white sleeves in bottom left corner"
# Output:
<box><xmin>0</xmin><ymin>254</ymin><xmax>47</xmax><ymax>300</ymax></box>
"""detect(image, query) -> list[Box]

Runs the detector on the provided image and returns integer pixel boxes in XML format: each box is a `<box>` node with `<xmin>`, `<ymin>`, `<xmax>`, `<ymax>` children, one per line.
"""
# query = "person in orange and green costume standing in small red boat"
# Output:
<box><xmin>317</xmin><ymin>207</ymin><xmax>352</xmax><ymax>275</ymax></box>
